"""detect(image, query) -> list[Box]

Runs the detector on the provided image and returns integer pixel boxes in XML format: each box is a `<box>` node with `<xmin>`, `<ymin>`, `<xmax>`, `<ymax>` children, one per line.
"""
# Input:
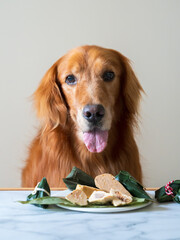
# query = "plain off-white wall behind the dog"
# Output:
<box><xmin>0</xmin><ymin>0</ymin><xmax>180</xmax><ymax>187</ymax></box>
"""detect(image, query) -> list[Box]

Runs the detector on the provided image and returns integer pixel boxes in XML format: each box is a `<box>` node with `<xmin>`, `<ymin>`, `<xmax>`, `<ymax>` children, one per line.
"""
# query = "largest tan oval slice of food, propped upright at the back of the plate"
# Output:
<box><xmin>94</xmin><ymin>173</ymin><xmax>131</xmax><ymax>197</ymax></box>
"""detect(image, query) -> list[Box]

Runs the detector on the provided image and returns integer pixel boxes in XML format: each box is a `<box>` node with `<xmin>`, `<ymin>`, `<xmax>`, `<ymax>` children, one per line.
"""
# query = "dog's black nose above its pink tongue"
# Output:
<box><xmin>83</xmin><ymin>104</ymin><xmax>105</xmax><ymax>124</ymax></box>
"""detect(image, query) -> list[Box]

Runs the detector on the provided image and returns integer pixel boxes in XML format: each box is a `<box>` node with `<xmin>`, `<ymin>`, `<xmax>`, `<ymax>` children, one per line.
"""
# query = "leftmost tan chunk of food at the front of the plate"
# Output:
<box><xmin>66</xmin><ymin>189</ymin><xmax>88</xmax><ymax>206</ymax></box>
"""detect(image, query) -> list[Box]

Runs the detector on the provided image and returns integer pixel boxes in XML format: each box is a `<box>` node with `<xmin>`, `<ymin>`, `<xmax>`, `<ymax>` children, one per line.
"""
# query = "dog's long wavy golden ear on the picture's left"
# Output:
<box><xmin>34</xmin><ymin>60</ymin><xmax>67</xmax><ymax>128</ymax></box>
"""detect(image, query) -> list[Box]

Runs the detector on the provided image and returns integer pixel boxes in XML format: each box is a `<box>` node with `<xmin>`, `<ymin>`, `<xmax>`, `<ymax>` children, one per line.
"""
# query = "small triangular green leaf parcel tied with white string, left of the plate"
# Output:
<box><xmin>27</xmin><ymin>177</ymin><xmax>51</xmax><ymax>208</ymax></box>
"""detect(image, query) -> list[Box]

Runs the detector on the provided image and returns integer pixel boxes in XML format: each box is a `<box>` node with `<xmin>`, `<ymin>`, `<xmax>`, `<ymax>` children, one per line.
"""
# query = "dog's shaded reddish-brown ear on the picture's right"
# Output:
<box><xmin>121</xmin><ymin>56</ymin><xmax>144</xmax><ymax>120</ymax></box>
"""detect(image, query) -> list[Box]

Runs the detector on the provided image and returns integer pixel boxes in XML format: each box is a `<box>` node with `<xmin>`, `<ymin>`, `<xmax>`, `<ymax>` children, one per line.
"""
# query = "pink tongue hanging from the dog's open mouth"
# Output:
<box><xmin>83</xmin><ymin>130</ymin><xmax>108</xmax><ymax>152</ymax></box>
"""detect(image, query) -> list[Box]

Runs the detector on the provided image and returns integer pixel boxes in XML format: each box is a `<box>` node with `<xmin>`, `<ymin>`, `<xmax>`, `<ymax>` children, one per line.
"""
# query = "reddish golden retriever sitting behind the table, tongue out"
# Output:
<box><xmin>22</xmin><ymin>46</ymin><xmax>143</xmax><ymax>187</ymax></box>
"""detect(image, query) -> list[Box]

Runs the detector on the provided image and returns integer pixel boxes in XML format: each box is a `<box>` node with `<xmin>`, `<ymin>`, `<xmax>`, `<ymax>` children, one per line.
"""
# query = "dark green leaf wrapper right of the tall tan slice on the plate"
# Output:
<box><xmin>115</xmin><ymin>171</ymin><xmax>152</xmax><ymax>200</ymax></box>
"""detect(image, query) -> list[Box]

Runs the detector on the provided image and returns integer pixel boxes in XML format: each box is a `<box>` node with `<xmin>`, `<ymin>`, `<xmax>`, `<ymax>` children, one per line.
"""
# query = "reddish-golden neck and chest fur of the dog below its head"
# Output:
<box><xmin>22</xmin><ymin>111</ymin><xmax>142</xmax><ymax>187</ymax></box>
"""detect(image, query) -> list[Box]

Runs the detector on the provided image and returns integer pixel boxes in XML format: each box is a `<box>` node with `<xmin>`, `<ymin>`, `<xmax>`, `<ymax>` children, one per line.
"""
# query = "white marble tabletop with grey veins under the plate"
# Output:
<box><xmin>0</xmin><ymin>190</ymin><xmax>180</xmax><ymax>240</ymax></box>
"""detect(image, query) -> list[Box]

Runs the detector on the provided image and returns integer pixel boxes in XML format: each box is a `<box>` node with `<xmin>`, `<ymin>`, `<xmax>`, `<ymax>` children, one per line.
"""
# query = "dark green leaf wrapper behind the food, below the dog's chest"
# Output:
<box><xmin>63</xmin><ymin>167</ymin><xmax>96</xmax><ymax>190</ymax></box>
